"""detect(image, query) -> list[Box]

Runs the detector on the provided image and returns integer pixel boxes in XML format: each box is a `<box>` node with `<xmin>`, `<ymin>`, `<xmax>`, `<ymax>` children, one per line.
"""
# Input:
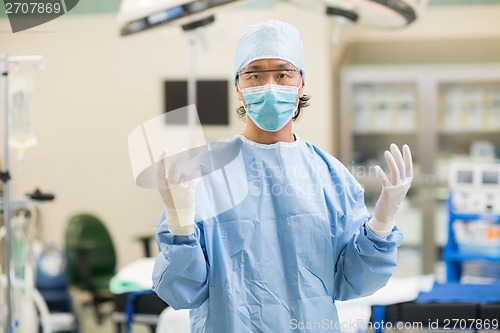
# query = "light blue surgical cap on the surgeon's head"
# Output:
<box><xmin>234</xmin><ymin>20</ymin><xmax>305</xmax><ymax>85</ymax></box>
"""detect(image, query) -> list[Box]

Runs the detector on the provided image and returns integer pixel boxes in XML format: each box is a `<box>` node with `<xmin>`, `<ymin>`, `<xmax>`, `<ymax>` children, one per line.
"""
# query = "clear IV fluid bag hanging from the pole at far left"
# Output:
<box><xmin>9</xmin><ymin>72</ymin><xmax>37</xmax><ymax>150</ymax></box>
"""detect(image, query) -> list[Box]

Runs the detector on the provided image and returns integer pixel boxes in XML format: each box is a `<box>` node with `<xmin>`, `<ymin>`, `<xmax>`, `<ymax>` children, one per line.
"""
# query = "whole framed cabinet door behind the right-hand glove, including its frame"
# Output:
<box><xmin>339</xmin><ymin>66</ymin><xmax>446</xmax><ymax>274</ymax></box>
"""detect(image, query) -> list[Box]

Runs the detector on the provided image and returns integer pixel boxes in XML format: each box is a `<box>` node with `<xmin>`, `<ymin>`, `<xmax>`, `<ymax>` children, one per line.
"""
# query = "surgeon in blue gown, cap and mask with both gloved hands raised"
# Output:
<box><xmin>153</xmin><ymin>21</ymin><xmax>413</xmax><ymax>333</ymax></box>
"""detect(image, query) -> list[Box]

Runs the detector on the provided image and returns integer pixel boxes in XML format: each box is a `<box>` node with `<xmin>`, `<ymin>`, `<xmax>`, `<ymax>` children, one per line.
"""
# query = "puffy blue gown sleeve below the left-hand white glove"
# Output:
<box><xmin>152</xmin><ymin>212</ymin><xmax>209</xmax><ymax>310</ymax></box>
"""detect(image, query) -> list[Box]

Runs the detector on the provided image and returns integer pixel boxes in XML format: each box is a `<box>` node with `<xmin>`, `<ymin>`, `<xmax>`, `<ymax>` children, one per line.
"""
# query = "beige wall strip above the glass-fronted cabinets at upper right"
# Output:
<box><xmin>343</xmin><ymin>4</ymin><xmax>500</xmax><ymax>57</ymax></box>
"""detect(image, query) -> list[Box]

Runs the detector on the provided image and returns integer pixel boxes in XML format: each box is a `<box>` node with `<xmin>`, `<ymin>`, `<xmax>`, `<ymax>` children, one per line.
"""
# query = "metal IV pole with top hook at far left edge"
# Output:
<box><xmin>0</xmin><ymin>53</ymin><xmax>44</xmax><ymax>333</ymax></box>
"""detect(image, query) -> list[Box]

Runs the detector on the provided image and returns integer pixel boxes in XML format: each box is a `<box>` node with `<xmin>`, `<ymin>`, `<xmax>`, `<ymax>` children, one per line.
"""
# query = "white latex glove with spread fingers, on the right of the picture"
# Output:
<box><xmin>368</xmin><ymin>143</ymin><xmax>413</xmax><ymax>237</ymax></box>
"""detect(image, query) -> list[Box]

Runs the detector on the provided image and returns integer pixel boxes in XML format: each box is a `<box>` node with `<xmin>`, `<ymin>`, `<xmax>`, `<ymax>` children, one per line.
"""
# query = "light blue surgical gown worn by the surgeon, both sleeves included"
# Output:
<box><xmin>153</xmin><ymin>136</ymin><xmax>403</xmax><ymax>333</ymax></box>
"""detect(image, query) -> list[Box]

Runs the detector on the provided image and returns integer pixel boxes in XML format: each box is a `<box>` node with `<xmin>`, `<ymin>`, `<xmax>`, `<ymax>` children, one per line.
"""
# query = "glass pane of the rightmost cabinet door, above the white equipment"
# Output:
<box><xmin>436</xmin><ymin>80</ymin><xmax>500</xmax><ymax>186</ymax></box>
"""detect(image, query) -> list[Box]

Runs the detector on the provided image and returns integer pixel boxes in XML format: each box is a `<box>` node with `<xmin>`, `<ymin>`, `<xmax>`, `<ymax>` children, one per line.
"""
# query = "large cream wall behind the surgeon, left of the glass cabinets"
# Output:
<box><xmin>0</xmin><ymin>4</ymin><xmax>333</xmax><ymax>266</ymax></box>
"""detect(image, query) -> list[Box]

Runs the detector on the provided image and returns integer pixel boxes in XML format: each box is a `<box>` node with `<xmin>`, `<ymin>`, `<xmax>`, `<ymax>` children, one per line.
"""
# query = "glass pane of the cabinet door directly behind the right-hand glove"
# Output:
<box><xmin>341</xmin><ymin>82</ymin><xmax>419</xmax><ymax>200</ymax></box>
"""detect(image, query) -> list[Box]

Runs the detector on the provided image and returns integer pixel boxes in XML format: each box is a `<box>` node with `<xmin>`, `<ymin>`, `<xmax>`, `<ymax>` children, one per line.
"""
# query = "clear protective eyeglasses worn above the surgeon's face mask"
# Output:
<box><xmin>238</xmin><ymin>68</ymin><xmax>302</xmax><ymax>87</ymax></box>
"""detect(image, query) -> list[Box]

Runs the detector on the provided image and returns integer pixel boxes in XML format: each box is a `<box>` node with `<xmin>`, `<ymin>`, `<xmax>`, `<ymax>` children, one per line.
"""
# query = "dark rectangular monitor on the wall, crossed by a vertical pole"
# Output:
<box><xmin>163</xmin><ymin>80</ymin><xmax>229</xmax><ymax>125</ymax></box>
